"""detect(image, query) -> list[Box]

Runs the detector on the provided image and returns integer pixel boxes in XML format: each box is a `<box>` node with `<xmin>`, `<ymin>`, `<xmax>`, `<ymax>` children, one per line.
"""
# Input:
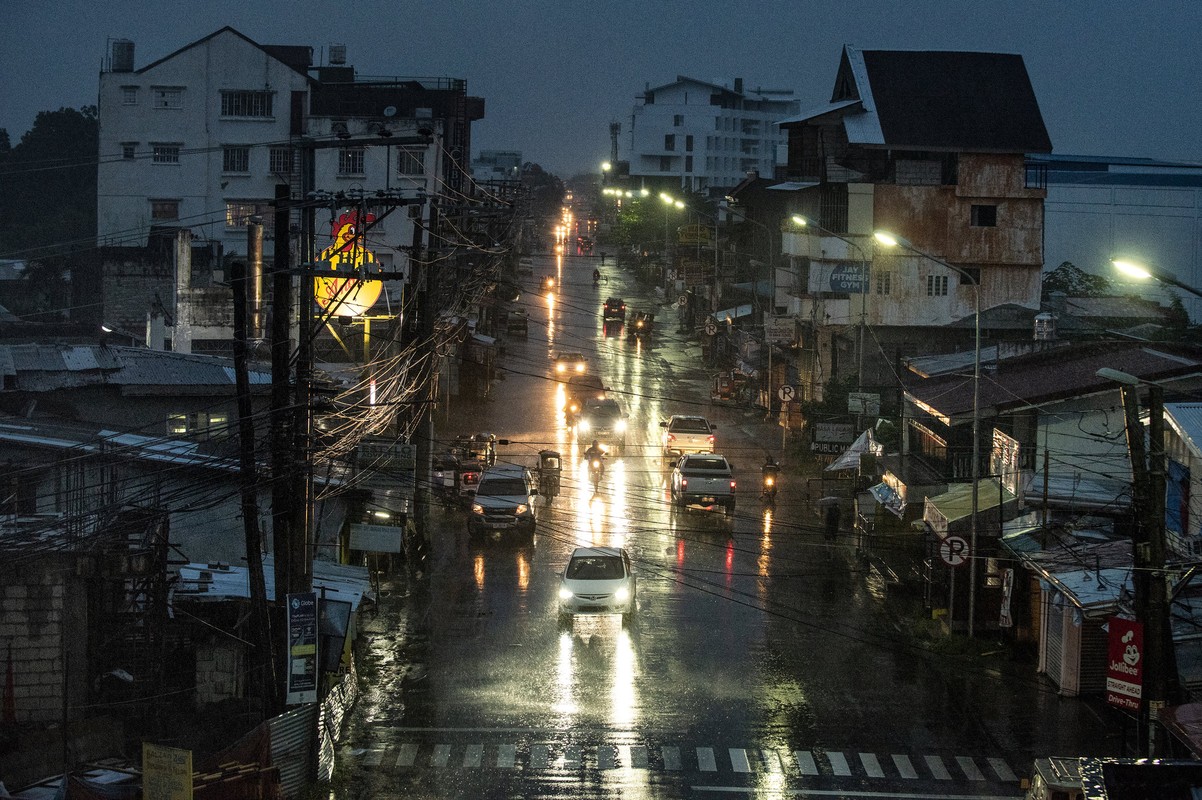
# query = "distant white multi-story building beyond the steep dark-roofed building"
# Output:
<box><xmin>629</xmin><ymin>76</ymin><xmax>799</xmax><ymax>195</ymax></box>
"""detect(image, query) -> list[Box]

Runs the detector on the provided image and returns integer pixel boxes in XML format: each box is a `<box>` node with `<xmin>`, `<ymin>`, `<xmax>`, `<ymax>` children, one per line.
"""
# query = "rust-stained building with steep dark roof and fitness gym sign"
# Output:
<box><xmin>773</xmin><ymin>47</ymin><xmax>1052</xmax><ymax>408</ymax></box>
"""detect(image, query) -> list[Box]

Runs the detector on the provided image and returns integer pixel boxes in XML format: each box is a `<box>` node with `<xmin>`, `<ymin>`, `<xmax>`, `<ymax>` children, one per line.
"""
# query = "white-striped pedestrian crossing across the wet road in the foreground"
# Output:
<box><xmin>349</xmin><ymin>742</ymin><xmax>1018</xmax><ymax>783</ymax></box>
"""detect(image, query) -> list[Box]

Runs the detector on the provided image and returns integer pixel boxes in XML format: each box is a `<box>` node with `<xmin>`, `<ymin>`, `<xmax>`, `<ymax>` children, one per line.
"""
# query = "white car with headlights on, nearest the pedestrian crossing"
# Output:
<box><xmin>559</xmin><ymin>548</ymin><xmax>637</xmax><ymax>626</ymax></box>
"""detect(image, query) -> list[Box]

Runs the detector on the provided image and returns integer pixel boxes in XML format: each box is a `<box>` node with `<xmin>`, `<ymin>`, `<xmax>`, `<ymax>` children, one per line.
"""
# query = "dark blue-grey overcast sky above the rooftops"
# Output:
<box><xmin>0</xmin><ymin>0</ymin><xmax>1202</xmax><ymax>178</ymax></box>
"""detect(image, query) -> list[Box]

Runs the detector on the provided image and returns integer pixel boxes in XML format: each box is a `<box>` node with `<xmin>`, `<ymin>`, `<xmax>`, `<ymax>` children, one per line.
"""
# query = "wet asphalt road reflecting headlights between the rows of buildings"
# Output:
<box><xmin>334</xmin><ymin>249</ymin><xmax>1112</xmax><ymax>800</ymax></box>
